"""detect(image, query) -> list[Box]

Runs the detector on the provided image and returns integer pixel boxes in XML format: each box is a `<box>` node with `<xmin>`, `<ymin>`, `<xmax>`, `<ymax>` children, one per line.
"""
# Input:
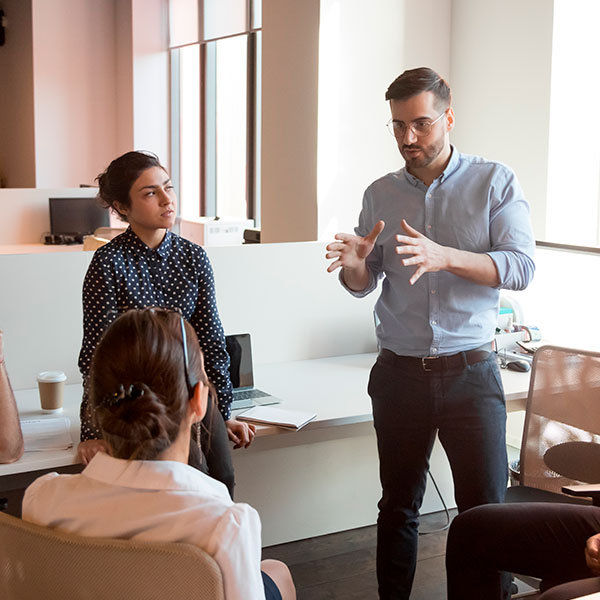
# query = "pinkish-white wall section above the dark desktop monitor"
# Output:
<box><xmin>32</xmin><ymin>0</ymin><xmax>117</xmax><ymax>188</ymax></box>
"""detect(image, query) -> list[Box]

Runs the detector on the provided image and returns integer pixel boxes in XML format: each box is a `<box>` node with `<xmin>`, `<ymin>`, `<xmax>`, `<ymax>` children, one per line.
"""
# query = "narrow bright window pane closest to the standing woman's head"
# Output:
<box><xmin>179</xmin><ymin>44</ymin><xmax>201</xmax><ymax>218</ymax></box>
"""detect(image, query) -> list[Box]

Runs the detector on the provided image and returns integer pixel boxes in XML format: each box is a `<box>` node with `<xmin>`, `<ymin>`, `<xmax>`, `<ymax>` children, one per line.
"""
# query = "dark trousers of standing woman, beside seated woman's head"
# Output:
<box><xmin>188</xmin><ymin>398</ymin><xmax>235</xmax><ymax>500</ymax></box>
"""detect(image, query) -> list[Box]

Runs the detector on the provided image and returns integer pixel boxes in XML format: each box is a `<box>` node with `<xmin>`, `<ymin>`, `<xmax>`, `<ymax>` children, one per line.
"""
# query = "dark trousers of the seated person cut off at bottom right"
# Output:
<box><xmin>446</xmin><ymin>503</ymin><xmax>600</xmax><ymax>600</ymax></box>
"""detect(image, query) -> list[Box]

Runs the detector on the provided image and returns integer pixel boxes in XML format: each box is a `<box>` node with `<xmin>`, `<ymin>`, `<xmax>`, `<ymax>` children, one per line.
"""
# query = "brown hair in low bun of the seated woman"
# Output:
<box><xmin>90</xmin><ymin>308</ymin><xmax>210</xmax><ymax>460</ymax></box>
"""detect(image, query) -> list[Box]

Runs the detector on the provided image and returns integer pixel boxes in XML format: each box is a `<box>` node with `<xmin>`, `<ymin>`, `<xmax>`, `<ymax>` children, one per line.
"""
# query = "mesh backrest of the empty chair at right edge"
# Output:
<box><xmin>520</xmin><ymin>346</ymin><xmax>600</xmax><ymax>493</ymax></box>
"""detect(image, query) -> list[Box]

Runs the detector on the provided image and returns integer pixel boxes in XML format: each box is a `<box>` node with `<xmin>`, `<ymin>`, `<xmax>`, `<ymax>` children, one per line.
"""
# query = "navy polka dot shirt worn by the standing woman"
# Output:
<box><xmin>79</xmin><ymin>227</ymin><xmax>232</xmax><ymax>440</ymax></box>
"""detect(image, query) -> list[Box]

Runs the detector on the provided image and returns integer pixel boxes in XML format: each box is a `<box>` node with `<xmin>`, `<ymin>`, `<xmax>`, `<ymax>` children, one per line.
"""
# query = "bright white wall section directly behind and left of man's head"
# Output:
<box><xmin>318</xmin><ymin>0</ymin><xmax>451</xmax><ymax>240</ymax></box>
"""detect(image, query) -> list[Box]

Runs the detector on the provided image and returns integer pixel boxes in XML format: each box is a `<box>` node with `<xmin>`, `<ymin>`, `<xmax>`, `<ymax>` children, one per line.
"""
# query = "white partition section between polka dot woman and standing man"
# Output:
<box><xmin>206</xmin><ymin>242</ymin><xmax>377</xmax><ymax>363</ymax></box>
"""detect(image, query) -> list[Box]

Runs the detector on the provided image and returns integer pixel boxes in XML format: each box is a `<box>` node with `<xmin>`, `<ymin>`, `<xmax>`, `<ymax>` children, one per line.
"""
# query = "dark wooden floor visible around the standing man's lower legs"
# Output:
<box><xmin>263</xmin><ymin>511</ymin><xmax>456</xmax><ymax>600</ymax></box>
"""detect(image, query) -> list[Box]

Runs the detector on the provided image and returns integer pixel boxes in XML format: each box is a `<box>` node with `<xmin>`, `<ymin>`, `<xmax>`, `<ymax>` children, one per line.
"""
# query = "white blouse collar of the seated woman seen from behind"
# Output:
<box><xmin>82</xmin><ymin>452</ymin><xmax>229</xmax><ymax>499</ymax></box>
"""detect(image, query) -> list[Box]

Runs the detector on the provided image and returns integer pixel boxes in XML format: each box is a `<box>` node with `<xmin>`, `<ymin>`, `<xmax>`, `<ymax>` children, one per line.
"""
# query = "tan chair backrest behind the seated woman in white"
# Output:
<box><xmin>0</xmin><ymin>513</ymin><xmax>224</xmax><ymax>600</ymax></box>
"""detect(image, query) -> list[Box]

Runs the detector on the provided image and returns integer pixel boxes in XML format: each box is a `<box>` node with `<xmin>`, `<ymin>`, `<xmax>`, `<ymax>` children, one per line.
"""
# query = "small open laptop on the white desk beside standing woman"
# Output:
<box><xmin>225</xmin><ymin>333</ymin><xmax>281</xmax><ymax>410</ymax></box>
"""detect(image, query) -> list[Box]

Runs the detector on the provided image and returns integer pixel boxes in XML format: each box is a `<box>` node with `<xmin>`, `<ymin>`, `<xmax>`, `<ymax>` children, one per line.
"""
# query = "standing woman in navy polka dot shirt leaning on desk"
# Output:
<box><xmin>78</xmin><ymin>152</ymin><xmax>254</xmax><ymax>491</ymax></box>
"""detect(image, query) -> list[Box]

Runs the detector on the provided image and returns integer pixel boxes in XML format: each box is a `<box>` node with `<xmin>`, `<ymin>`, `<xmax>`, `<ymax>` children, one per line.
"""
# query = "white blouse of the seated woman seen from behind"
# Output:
<box><xmin>23</xmin><ymin>452</ymin><xmax>265</xmax><ymax>600</ymax></box>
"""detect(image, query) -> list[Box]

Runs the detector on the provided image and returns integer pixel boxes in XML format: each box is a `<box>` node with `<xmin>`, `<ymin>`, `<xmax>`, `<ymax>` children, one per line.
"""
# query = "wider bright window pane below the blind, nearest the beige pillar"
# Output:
<box><xmin>213</xmin><ymin>35</ymin><xmax>248</xmax><ymax>219</ymax></box>
